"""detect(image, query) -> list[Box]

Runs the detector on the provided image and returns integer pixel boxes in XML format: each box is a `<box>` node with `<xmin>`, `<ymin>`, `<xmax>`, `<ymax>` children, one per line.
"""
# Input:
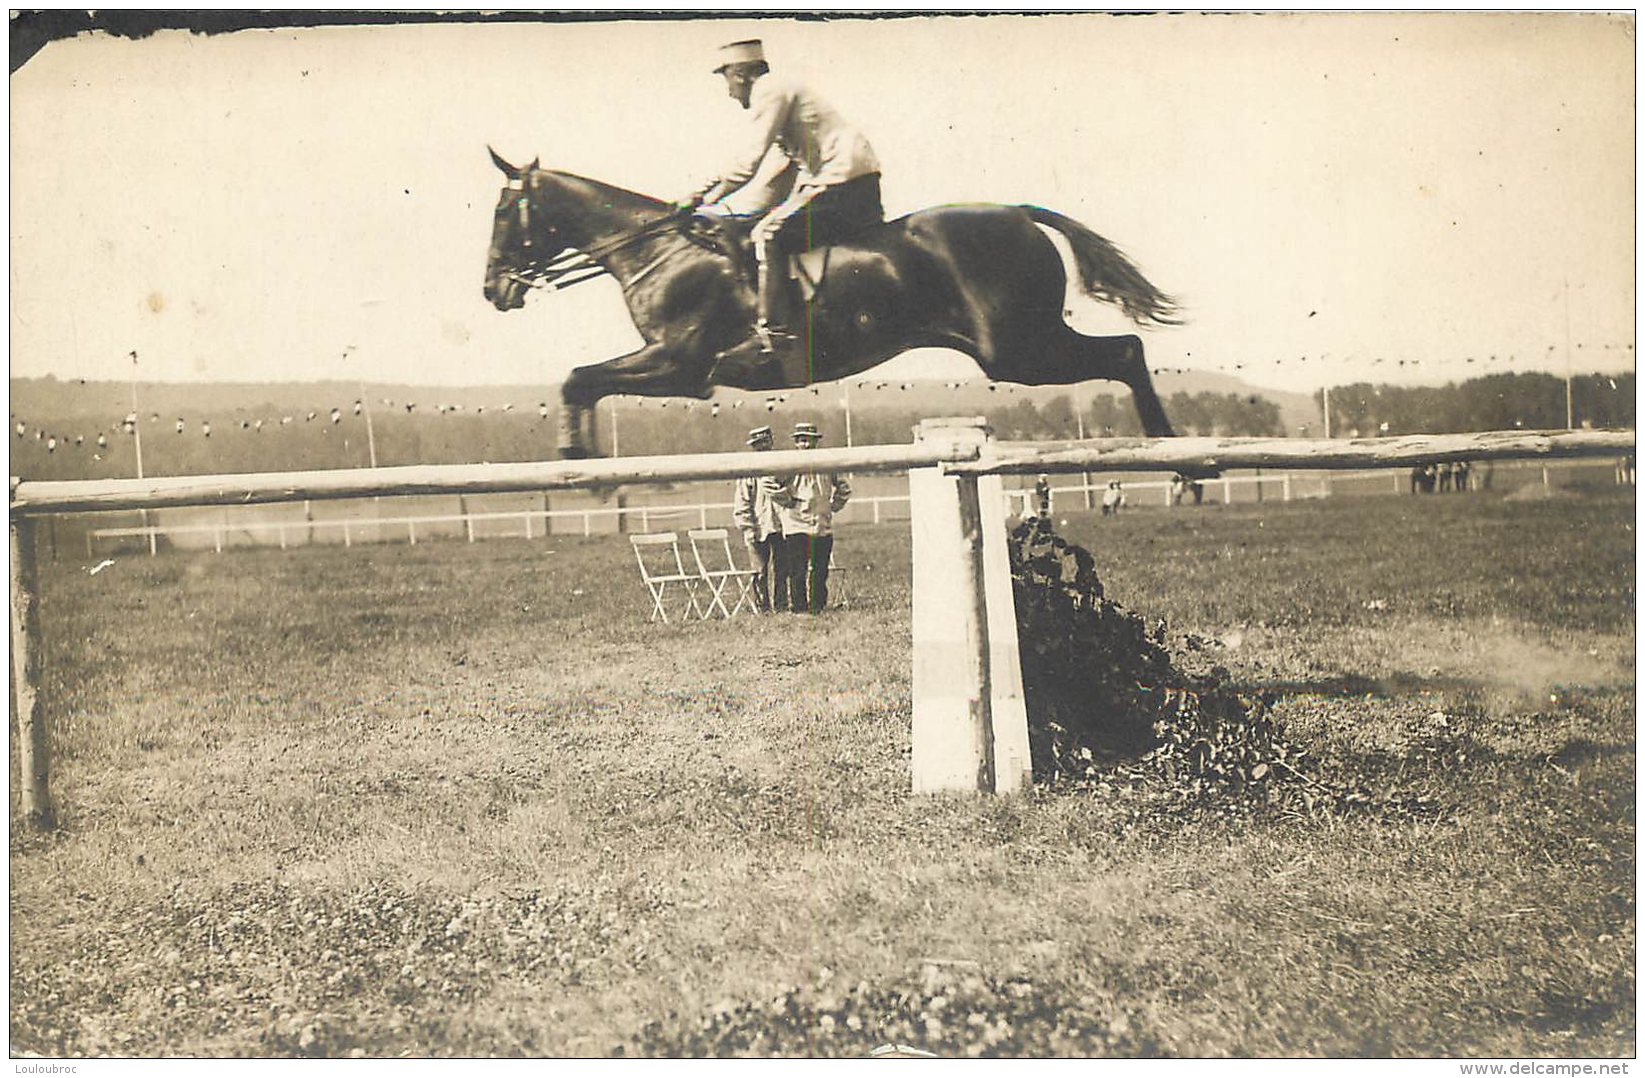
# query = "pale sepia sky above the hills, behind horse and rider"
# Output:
<box><xmin>10</xmin><ymin>13</ymin><xmax>1635</xmax><ymax>390</ymax></box>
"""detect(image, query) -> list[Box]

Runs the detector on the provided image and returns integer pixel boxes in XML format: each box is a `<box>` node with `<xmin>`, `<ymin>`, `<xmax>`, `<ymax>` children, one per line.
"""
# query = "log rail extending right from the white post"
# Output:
<box><xmin>943</xmin><ymin>431</ymin><xmax>1635</xmax><ymax>476</ymax></box>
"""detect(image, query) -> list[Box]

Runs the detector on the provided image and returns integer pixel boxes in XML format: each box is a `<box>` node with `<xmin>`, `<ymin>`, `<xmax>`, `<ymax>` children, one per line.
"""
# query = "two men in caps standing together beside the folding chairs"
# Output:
<box><xmin>732</xmin><ymin>423</ymin><xmax>850</xmax><ymax>614</ymax></box>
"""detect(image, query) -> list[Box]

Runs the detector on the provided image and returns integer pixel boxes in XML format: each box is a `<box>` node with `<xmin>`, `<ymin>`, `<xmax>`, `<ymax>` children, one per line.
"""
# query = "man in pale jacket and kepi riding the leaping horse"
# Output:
<box><xmin>676</xmin><ymin>41</ymin><xmax>885</xmax><ymax>360</ymax></box>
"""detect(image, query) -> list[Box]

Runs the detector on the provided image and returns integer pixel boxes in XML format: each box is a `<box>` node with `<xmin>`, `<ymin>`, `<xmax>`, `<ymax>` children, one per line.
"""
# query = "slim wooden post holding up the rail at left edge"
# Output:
<box><xmin>12</xmin><ymin>497</ymin><xmax>56</xmax><ymax>831</ymax></box>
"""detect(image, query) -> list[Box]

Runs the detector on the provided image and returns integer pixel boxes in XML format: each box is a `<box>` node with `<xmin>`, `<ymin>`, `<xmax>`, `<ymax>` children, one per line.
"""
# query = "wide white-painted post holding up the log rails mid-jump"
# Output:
<box><xmin>908</xmin><ymin>418</ymin><xmax>1030</xmax><ymax>793</ymax></box>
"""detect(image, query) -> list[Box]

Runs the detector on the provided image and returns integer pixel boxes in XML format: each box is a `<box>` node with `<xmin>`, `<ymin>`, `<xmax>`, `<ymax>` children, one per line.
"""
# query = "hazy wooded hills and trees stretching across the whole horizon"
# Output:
<box><xmin>10</xmin><ymin>374</ymin><xmax>1633</xmax><ymax>479</ymax></box>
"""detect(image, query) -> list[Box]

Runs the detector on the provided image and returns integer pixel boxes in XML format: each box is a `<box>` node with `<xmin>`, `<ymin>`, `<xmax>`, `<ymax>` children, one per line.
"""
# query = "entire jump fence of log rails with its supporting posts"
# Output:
<box><xmin>10</xmin><ymin>418</ymin><xmax>1635</xmax><ymax>829</ymax></box>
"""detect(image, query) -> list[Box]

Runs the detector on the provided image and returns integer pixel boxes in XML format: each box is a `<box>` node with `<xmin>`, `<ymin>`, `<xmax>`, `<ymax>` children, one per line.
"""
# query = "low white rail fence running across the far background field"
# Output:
<box><xmin>86</xmin><ymin>459</ymin><xmax>1632</xmax><ymax>558</ymax></box>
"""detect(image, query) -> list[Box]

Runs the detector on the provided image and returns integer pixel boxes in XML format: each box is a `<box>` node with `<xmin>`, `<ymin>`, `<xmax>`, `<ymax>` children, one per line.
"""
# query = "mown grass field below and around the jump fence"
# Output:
<box><xmin>10</xmin><ymin>489</ymin><xmax>1637</xmax><ymax>1057</ymax></box>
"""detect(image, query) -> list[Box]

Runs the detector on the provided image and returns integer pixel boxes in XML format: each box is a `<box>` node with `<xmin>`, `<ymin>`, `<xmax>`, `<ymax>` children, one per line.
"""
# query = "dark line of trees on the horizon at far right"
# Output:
<box><xmin>1314</xmin><ymin>372</ymin><xmax>1635</xmax><ymax>438</ymax></box>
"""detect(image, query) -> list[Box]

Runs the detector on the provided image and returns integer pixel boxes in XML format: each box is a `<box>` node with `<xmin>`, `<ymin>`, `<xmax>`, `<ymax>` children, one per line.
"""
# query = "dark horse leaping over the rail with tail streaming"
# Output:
<box><xmin>484</xmin><ymin>150</ymin><xmax>1178</xmax><ymax>459</ymax></box>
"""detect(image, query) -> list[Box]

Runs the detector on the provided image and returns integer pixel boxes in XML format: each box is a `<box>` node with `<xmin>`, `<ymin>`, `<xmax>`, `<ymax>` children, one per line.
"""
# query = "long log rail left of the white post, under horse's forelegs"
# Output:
<box><xmin>12</xmin><ymin>441</ymin><xmax>980</xmax><ymax>515</ymax></box>
